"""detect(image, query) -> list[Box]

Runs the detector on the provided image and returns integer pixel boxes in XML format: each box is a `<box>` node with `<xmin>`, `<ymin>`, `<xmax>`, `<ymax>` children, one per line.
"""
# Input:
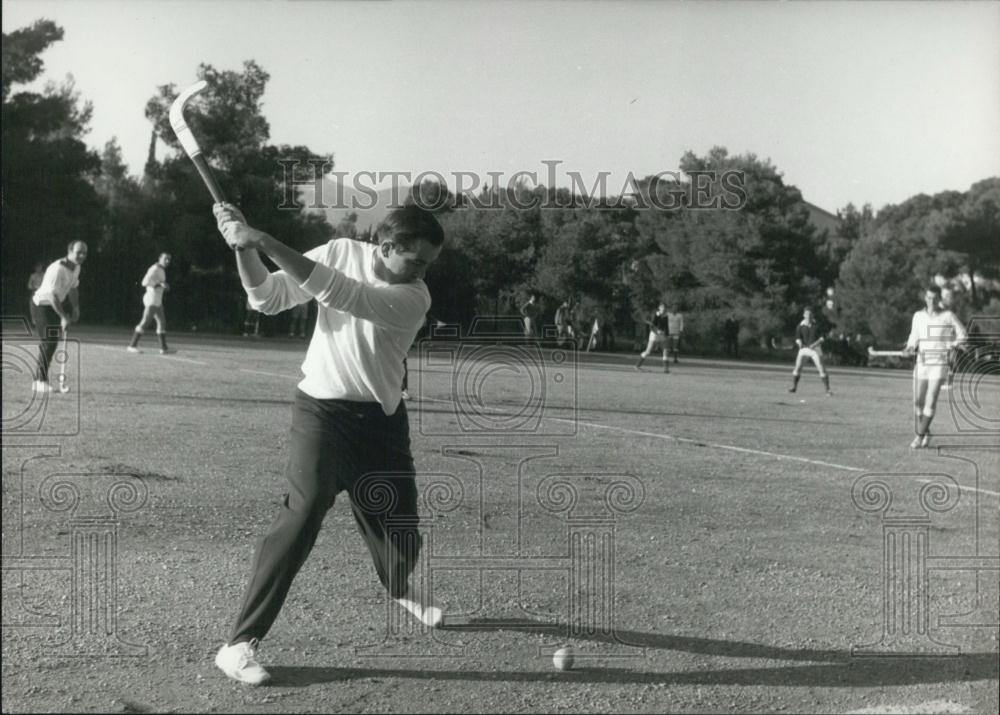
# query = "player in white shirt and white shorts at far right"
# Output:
<box><xmin>904</xmin><ymin>285</ymin><xmax>966</xmax><ymax>449</ymax></box>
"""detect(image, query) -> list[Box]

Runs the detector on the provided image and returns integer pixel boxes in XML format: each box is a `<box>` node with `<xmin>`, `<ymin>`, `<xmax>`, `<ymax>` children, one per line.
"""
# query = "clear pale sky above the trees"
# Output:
<box><xmin>3</xmin><ymin>0</ymin><xmax>1000</xmax><ymax>211</ymax></box>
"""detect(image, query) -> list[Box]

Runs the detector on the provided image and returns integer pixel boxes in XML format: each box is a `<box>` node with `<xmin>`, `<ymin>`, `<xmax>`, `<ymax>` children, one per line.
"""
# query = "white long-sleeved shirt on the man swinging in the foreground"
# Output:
<box><xmin>247</xmin><ymin>238</ymin><xmax>431</xmax><ymax>415</ymax></box>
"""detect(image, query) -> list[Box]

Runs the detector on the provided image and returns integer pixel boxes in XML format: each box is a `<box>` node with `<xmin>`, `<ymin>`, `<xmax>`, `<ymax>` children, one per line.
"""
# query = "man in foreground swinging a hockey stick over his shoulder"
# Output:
<box><xmin>209</xmin><ymin>204</ymin><xmax>444</xmax><ymax>685</ymax></box>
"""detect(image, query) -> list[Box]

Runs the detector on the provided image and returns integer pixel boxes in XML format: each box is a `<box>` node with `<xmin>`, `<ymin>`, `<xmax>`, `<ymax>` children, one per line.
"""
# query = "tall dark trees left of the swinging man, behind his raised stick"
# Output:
<box><xmin>2</xmin><ymin>20</ymin><xmax>333</xmax><ymax>327</ymax></box>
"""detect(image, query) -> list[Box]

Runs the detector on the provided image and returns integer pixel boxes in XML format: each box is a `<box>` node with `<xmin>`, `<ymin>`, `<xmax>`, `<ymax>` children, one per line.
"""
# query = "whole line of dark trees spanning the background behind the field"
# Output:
<box><xmin>2</xmin><ymin>21</ymin><xmax>1000</xmax><ymax>350</ymax></box>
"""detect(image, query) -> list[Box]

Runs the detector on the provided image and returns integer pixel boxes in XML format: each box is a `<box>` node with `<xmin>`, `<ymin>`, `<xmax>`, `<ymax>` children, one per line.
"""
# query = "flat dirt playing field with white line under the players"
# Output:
<box><xmin>3</xmin><ymin>328</ymin><xmax>1000</xmax><ymax>713</ymax></box>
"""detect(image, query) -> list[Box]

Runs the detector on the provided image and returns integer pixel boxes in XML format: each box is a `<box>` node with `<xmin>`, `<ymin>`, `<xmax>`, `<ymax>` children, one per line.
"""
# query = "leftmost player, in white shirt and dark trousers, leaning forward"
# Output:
<box><xmin>31</xmin><ymin>241</ymin><xmax>87</xmax><ymax>393</ymax></box>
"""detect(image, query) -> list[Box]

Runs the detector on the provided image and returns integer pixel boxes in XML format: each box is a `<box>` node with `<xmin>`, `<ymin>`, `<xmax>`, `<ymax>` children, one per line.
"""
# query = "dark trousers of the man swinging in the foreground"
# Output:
<box><xmin>229</xmin><ymin>390</ymin><xmax>421</xmax><ymax>644</ymax></box>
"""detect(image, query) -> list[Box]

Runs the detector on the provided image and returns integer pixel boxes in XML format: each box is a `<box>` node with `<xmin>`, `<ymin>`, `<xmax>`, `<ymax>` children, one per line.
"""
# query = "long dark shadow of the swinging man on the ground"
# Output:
<box><xmin>269</xmin><ymin>619</ymin><xmax>1000</xmax><ymax>688</ymax></box>
